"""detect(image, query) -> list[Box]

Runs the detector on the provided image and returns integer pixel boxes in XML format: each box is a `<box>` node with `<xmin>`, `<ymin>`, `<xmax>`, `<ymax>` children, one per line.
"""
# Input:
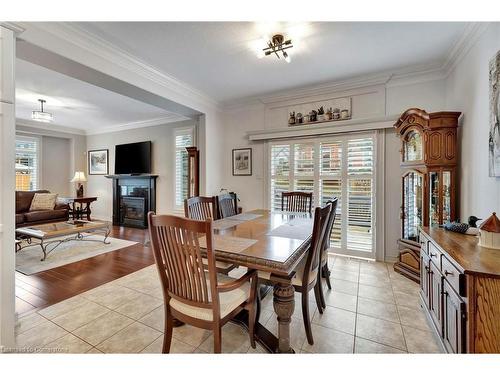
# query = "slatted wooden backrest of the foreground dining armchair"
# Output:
<box><xmin>148</xmin><ymin>212</ymin><xmax>218</xmax><ymax>309</ymax></box>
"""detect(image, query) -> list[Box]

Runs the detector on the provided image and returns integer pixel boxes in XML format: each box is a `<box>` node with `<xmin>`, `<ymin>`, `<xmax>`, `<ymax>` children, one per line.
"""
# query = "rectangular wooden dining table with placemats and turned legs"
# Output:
<box><xmin>205</xmin><ymin>210</ymin><xmax>313</xmax><ymax>353</ymax></box>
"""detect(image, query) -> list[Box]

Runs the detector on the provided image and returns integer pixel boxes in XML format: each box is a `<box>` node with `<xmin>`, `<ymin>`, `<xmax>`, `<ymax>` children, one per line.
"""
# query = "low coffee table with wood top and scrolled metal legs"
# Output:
<box><xmin>16</xmin><ymin>220</ymin><xmax>111</xmax><ymax>261</ymax></box>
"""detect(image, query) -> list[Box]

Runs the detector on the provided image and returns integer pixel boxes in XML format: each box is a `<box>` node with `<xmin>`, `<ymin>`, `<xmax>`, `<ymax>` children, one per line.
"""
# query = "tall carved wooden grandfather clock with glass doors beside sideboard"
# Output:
<box><xmin>394</xmin><ymin>108</ymin><xmax>460</xmax><ymax>282</ymax></box>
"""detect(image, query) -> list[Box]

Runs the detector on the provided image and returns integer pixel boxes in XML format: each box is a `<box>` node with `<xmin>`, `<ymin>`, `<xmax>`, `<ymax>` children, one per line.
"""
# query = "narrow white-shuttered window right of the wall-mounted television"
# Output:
<box><xmin>175</xmin><ymin>128</ymin><xmax>194</xmax><ymax>210</ymax></box>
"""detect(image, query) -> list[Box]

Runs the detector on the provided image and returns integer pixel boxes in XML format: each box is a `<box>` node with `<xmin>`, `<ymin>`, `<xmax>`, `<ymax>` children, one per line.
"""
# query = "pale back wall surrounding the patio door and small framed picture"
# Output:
<box><xmin>222</xmin><ymin>80</ymin><xmax>445</xmax><ymax>260</ymax></box>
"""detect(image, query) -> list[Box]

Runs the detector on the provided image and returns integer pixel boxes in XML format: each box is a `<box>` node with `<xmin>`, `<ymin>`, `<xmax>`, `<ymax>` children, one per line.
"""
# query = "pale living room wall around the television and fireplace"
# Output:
<box><xmin>84</xmin><ymin>120</ymin><xmax>197</xmax><ymax>221</ymax></box>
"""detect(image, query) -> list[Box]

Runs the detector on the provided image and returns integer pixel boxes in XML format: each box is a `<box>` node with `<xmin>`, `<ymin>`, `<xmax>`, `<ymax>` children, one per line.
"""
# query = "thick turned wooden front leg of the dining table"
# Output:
<box><xmin>273</xmin><ymin>280</ymin><xmax>295</xmax><ymax>353</ymax></box>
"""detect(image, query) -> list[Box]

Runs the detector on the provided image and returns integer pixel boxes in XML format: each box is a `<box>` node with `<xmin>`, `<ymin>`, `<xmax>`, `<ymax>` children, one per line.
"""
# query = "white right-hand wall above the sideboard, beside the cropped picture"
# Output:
<box><xmin>446</xmin><ymin>23</ymin><xmax>500</xmax><ymax>221</ymax></box>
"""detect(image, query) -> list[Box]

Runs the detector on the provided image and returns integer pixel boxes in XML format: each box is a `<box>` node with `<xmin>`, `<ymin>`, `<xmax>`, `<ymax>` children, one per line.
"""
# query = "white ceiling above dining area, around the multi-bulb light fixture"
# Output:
<box><xmin>74</xmin><ymin>22</ymin><xmax>467</xmax><ymax>102</ymax></box>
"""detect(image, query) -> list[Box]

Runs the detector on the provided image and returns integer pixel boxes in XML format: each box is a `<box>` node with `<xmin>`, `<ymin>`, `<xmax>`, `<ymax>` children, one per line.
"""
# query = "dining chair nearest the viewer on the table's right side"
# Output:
<box><xmin>258</xmin><ymin>204</ymin><xmax>332</xmax><ymax>345</ymax></box>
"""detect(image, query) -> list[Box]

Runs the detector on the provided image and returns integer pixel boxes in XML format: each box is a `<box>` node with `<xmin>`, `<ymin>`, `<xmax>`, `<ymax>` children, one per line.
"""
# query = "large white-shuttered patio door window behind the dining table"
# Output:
<box><xmin>269</xmin><ymin>134</ymin><xmax>375</xmax><ymax>255</ymax></box>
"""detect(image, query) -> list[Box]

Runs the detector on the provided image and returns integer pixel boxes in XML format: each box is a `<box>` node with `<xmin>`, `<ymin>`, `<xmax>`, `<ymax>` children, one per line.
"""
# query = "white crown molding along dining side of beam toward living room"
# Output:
<box><xmin>18</xmin><ymin>22</ymin><xmax>219</xmax><ymax>110</ymax></box>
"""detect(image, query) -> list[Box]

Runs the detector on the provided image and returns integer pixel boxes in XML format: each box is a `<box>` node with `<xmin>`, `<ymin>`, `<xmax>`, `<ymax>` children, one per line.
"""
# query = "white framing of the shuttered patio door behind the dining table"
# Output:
<box><xmin>266</xmin><ymin>131</ymin><xmax>376</xmax><ymax>259</ymax></box>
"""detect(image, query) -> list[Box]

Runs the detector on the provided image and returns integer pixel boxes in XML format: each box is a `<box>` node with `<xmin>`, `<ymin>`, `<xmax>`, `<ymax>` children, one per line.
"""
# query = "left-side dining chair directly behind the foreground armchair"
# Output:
<box><xmin>184</xmin><ymin>197</ymin><xmax>237</xmax><ymax>275</ymax></box>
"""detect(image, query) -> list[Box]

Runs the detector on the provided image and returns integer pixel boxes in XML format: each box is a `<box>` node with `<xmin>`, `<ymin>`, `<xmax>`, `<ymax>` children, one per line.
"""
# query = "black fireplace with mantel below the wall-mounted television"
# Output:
<box><xmin>106</xmin><ymin>175</ymin><xmax>158</xmax><ymax>228</ymax></box>
